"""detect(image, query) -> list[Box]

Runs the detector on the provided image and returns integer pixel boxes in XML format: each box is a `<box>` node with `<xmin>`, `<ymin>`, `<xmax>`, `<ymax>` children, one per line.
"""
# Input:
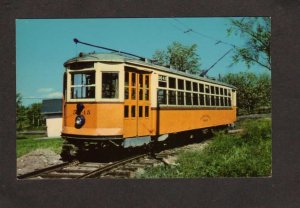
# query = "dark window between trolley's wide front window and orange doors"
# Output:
<box><xmin>102</xmin><ymin>72</ymin><xmax>119</xmax><ymax>98</ymax></box>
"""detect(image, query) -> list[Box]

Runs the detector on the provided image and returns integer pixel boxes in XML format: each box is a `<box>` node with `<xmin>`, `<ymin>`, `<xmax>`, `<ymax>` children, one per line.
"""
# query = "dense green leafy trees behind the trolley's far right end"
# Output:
<box><xmin>222</xmin><ymin>72</ymin><xmax>271</xmax><ymax>113</ymax></box>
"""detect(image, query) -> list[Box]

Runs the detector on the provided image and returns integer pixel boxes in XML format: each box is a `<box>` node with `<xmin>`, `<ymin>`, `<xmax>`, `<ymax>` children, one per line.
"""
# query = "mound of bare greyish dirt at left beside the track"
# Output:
<box><xmin>17</xmin><ymin>149</ymin><xmax>62</xmax><ymax>175</ymax></box>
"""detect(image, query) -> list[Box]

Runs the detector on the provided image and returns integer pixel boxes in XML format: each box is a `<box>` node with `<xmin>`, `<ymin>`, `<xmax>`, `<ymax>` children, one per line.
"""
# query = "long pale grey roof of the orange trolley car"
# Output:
<box><xmin>64</xmin><ymin>53</ymin><xmax>236</xmax><ymax>89</ymax></box>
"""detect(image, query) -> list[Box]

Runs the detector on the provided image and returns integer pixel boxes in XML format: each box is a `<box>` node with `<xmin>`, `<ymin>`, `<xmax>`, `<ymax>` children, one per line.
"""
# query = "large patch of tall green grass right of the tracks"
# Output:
<box><xmin>138</xmin><ymin>119</ymin><xmax>272</xmax><ymax>178</ymax></box>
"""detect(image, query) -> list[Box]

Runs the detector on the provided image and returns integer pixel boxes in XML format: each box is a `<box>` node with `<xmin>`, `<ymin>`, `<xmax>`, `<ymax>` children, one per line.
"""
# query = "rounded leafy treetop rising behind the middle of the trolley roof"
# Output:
<box><xmin>152</xmin><ymin>42</ymin><xmax>200</xmax><ymax>73</ymax></box>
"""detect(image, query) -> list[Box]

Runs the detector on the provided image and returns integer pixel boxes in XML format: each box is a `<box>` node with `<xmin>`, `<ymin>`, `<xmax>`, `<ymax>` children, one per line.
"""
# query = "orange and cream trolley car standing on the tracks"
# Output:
<box><xmin>62</xmin><ymin>53</ymin><xmax>236</xmax><ymax>159</ymax></box>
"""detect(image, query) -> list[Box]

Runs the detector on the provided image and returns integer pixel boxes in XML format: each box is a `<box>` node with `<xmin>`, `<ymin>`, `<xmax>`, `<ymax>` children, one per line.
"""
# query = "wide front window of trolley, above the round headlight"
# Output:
<box><xmin>71</xmin><ymin>71</ymin><xmax>95</xmax><ymax>99</ymax></box>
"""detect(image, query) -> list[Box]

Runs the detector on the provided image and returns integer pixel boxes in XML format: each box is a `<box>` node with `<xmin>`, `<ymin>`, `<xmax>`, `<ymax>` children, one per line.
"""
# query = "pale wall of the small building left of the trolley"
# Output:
<box><xmin>46</xmin><ymin>116</ymin><xmax>62</xmax><ymax>137</ymax></box>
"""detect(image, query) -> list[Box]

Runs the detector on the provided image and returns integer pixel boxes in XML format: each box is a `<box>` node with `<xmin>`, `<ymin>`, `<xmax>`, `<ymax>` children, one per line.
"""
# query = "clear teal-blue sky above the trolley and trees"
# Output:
<box><xmin>16</xmin><ymin>18</ymin><xmax>268</xmax><ymax>106</ymax></box>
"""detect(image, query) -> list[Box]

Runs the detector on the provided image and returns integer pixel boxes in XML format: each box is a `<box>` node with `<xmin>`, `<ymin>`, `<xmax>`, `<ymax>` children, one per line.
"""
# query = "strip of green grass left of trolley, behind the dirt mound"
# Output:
<box><xmin>16</xmin><ymin>135</ymin><xmax>63</xmax><ymax>158</ymax></box>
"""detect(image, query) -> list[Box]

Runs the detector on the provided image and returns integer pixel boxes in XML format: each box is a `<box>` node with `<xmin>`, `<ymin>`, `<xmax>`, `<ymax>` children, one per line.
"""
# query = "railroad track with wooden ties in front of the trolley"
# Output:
<box><xmin>17</xmin><ymin>154</ymin><xmax>160</xmax><ymax>179</ymax></box>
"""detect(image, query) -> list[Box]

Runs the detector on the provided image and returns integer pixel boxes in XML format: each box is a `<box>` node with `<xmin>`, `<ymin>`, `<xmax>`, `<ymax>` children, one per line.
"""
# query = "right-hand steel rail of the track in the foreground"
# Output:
<box><xmin>76</xmin><ymin>154</ymin><xmax>148</xmax><ymax>179</ymax></box>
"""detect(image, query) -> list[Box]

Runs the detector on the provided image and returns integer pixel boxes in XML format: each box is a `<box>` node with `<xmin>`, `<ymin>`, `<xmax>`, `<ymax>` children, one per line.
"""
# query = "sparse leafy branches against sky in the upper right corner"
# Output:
<box><xmin>227</xmin><ymin>17</ymin><xmax>271</xmax><ymax>71</ymax></box>
